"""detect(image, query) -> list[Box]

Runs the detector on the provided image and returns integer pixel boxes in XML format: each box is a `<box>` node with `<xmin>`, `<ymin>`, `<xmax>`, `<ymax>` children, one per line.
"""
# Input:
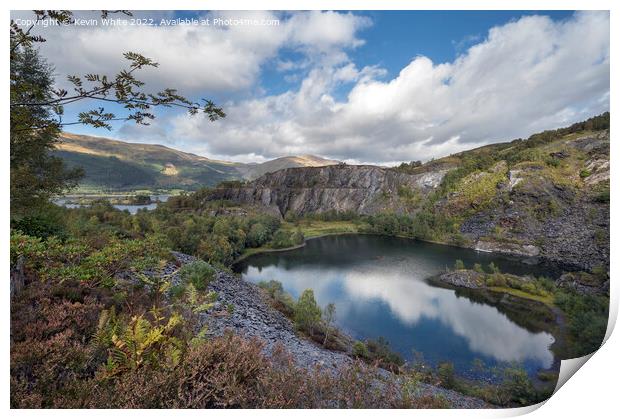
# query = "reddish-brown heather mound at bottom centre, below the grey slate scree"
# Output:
<box><xmin>81</xmin><ymin>335</ymin><xmax>426</xmax><ymax>408</ymax></box>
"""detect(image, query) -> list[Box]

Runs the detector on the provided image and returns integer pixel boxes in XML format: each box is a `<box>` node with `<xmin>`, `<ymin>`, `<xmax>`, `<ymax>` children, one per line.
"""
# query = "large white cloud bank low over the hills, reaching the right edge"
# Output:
<box><xmin>168</xmin><ymin>12</ymin><xmax>610</xmax><ymax>163</ymax></box>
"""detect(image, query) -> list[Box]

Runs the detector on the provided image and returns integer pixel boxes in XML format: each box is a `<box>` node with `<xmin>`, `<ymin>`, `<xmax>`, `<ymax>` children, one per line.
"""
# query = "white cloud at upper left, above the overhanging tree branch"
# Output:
<box><xmin>17</xmin><ymin>11</ymin><xmax>369</xmax><ymax>95</ymax></box>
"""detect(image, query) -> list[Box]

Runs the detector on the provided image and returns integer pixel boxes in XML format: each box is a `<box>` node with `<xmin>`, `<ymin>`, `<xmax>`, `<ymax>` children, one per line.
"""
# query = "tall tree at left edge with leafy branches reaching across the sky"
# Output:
<box><xmin>10</xmin><ymin>10</ymin><xmax>226</xmax><ymax>216</ymax></box>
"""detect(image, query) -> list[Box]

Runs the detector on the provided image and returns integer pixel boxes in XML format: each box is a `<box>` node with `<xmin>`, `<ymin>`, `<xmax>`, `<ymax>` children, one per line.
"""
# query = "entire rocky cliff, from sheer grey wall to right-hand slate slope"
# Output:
<box><xmin>209</xmin><ymin>130</ymin><xmax>610</xmax><ymax>271</ymax></box>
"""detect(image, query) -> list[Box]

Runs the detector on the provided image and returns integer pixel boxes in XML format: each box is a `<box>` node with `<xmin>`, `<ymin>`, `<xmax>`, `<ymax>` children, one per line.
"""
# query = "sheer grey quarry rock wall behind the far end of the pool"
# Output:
<box><xmin>214</xmin><ymin>165</ymin><xmax>447</xmax><ymax>215</ymax></box>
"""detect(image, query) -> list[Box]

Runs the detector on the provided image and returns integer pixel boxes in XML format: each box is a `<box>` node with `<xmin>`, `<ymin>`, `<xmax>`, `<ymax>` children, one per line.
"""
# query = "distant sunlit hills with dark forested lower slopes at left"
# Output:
<box><xmin>55</xmin><ymin>133</ymin><xmax>338</xmax><ymax>190</ymax></box>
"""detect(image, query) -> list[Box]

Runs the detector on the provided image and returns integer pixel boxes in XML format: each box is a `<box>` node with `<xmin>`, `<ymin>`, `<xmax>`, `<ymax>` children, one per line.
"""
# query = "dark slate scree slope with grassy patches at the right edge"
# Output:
<box><xmin>460</xmin><ymin>131</ymin><xmax>610</xmax><ymax>271</ymax></box>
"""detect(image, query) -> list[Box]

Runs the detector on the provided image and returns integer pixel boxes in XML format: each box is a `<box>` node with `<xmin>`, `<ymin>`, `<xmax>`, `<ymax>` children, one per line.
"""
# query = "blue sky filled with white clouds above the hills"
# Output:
<box><xmin>12</xmin><ymin>11</ymin><xmax>610</xmax><ymax>165</ymax></box>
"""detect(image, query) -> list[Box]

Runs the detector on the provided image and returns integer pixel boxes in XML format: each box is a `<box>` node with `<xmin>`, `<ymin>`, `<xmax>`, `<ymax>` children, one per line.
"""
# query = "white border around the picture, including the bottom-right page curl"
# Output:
<box><xmin>0</xmin><ymin>0</ymin><xmax>620</xmax><ymax>418</ymax></box>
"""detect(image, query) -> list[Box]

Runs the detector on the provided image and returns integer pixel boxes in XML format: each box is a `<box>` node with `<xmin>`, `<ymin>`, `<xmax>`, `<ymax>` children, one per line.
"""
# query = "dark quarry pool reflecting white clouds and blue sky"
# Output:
<box><xmin>235</xmin><ymin>235</ymin><xmax>556</xmax><ymax>375</ymax></box>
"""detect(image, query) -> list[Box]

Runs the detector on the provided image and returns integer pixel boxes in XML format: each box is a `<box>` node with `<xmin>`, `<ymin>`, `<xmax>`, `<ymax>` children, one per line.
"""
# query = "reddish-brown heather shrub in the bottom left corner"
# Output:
<box><xmin>10</xmin><ymin>270</ymin><xmax>104</xmax><ymax>408</ymax></box>
